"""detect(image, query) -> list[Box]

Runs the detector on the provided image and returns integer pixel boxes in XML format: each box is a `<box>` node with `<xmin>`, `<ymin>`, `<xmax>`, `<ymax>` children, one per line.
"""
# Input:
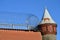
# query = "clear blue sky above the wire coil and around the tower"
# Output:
<box><xmin>0</xmin><ymin>0</ymin><xmax>60</xmax><ymax>40</ymax></box>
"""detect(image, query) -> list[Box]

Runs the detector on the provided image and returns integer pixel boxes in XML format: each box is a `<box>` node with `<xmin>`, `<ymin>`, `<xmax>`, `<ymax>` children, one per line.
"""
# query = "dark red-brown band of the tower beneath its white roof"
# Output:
<box><xmin>38</xmin><ymin>24</ymin><xmax>56</xmax><ymax>34</ymax></box>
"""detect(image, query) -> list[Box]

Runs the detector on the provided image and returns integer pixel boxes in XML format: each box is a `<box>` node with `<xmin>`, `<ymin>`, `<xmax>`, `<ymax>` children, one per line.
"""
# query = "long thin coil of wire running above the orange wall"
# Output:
<box><xmin>0</xmin><ymin>12</ymin><xmax>39</xmax><ymax>29</ymax></box>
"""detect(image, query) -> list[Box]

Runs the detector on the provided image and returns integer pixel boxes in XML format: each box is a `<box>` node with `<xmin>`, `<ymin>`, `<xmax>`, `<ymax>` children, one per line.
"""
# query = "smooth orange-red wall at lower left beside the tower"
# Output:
<box><xmin>0</xmin><ymin>30</ymin><xmax>42</xmax><ymax>40</ymax></box>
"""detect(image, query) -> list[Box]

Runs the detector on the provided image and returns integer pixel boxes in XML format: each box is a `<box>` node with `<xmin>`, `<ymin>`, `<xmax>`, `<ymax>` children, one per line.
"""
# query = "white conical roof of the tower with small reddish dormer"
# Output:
<box><xmin>40</xmin><ymin>8</ymin><xmax>56</xmax><ymax>24</ymax></box>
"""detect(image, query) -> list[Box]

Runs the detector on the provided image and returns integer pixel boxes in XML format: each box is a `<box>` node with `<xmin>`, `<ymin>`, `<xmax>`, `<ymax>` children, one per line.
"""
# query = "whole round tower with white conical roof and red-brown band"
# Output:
<box><xmin>38</xmin><ymin>9</ymin><xmax>57</xmax><ymax>40</ymax></box>
